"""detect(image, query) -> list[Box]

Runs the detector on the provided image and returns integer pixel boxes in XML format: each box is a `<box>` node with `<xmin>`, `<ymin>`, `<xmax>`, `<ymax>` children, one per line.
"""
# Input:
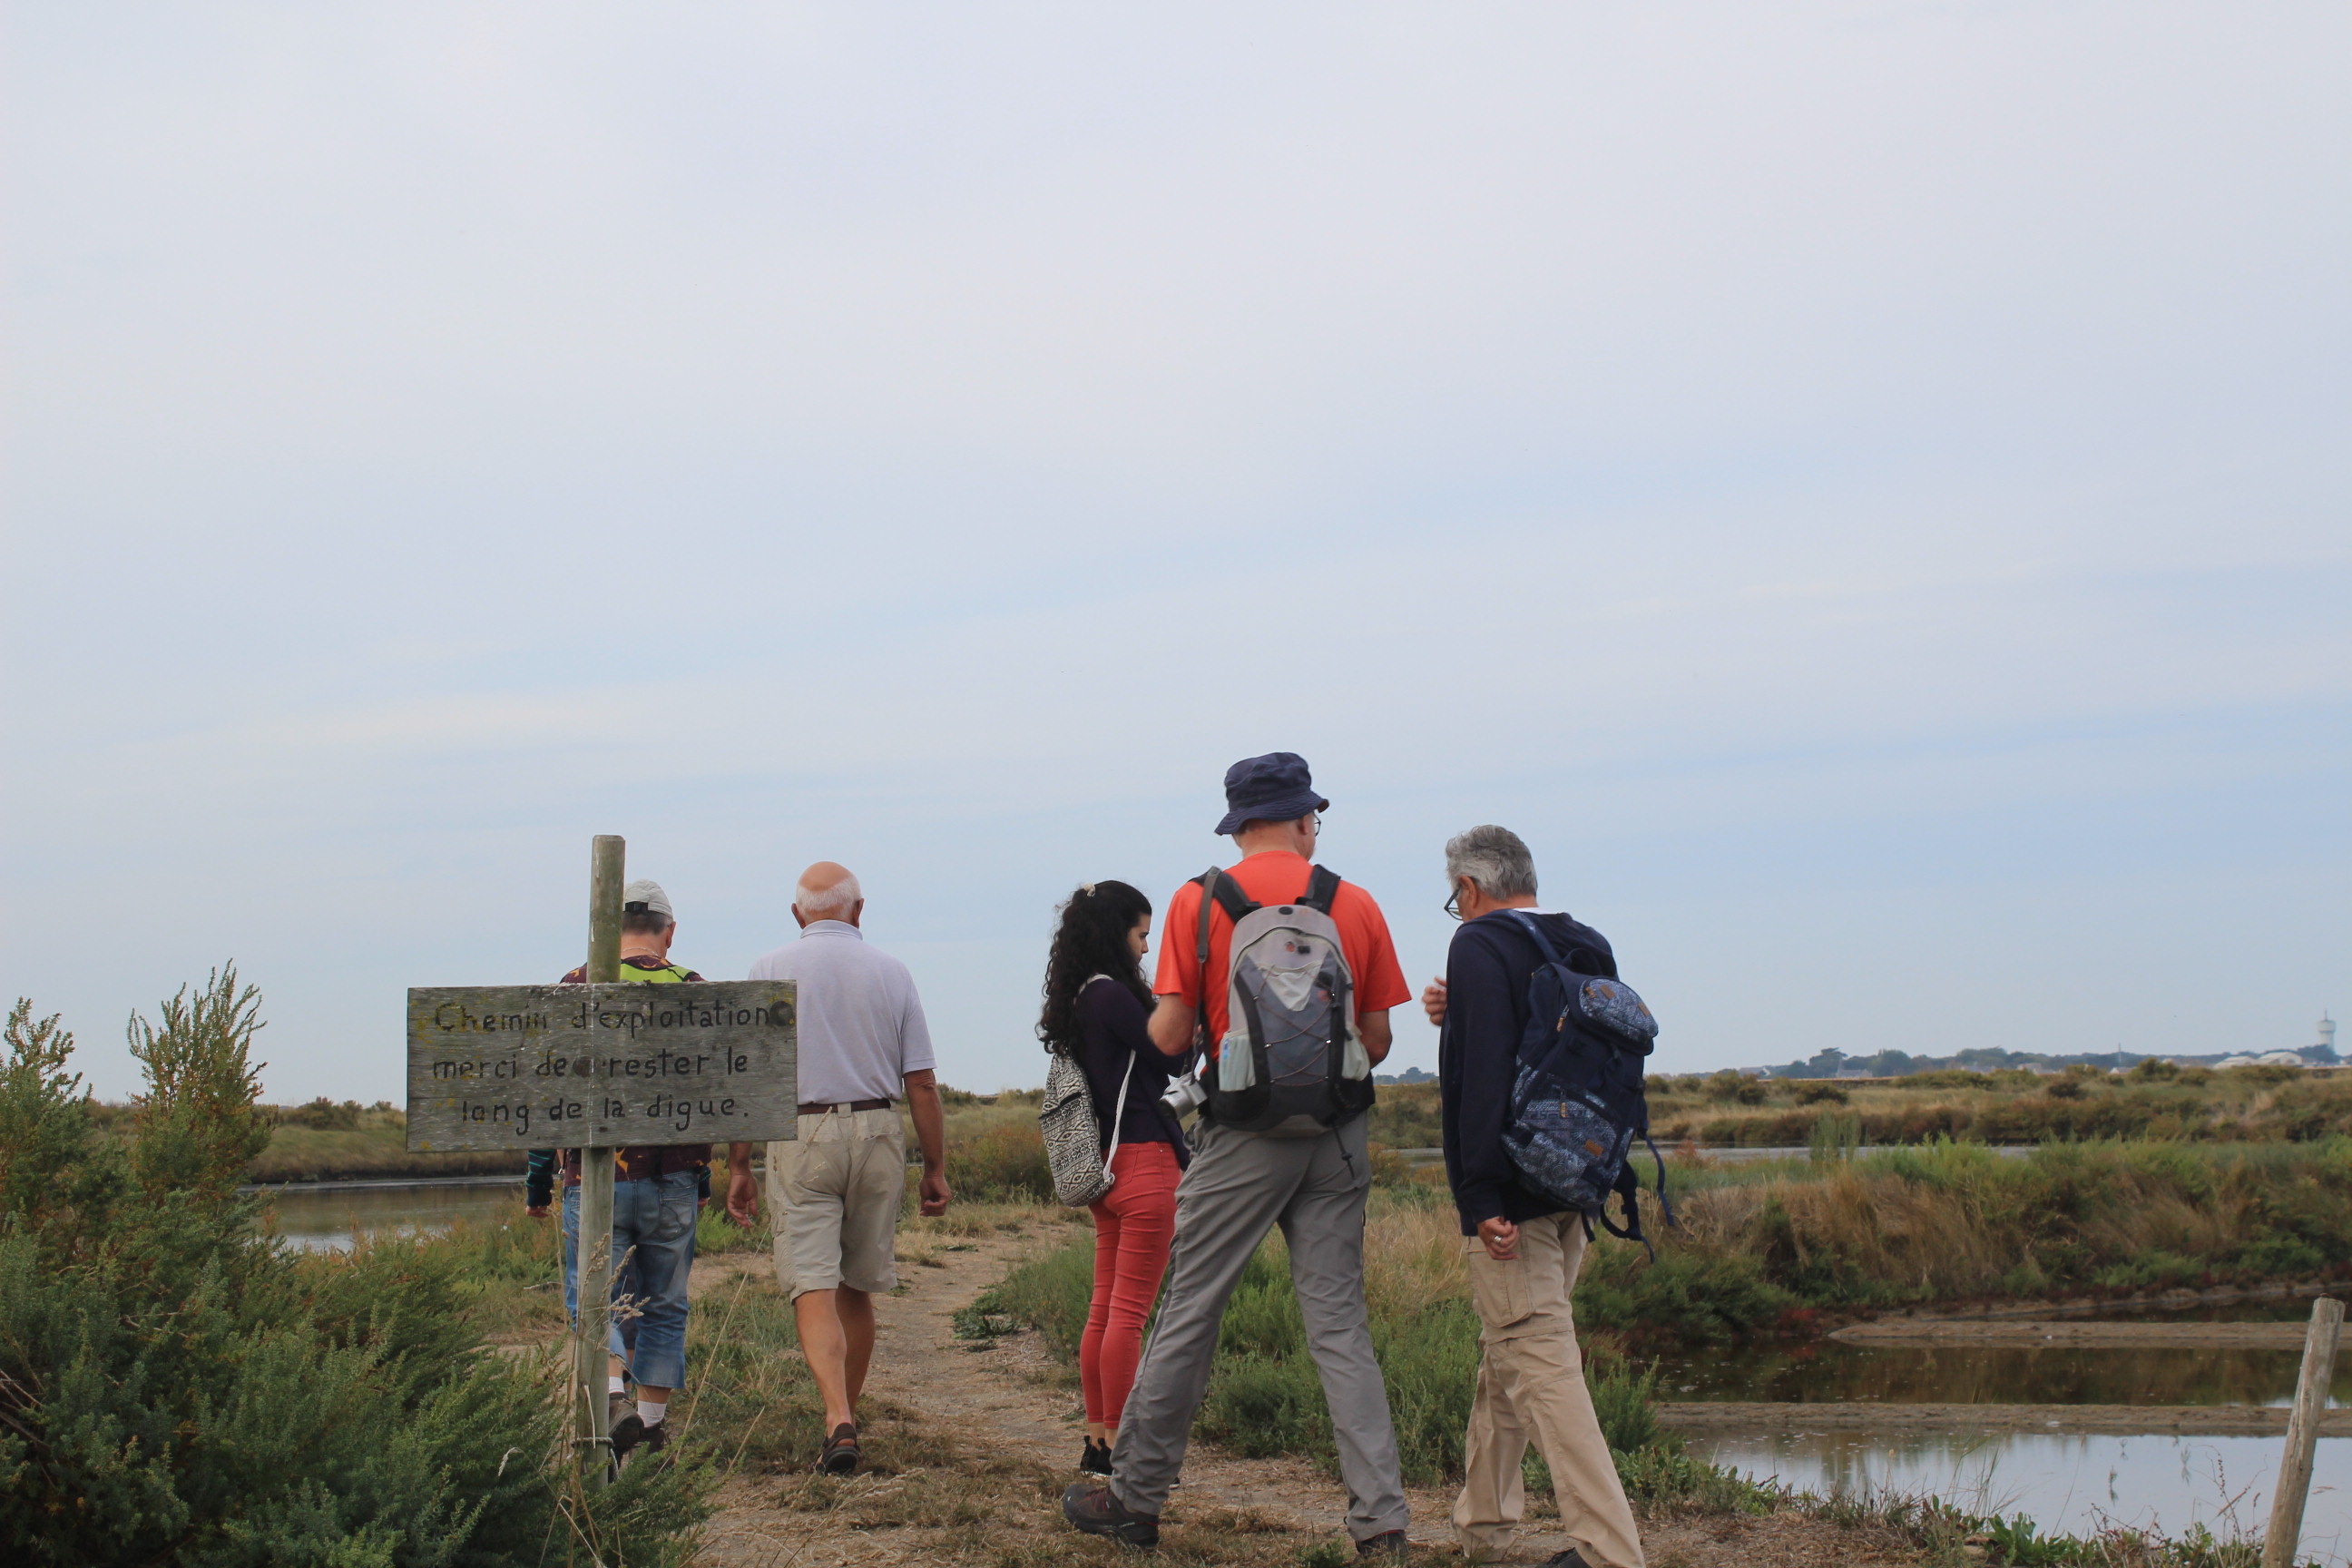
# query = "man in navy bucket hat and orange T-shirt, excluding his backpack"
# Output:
<box><xmin>1063</xmin><ymin>752</ymin><xmax>1411</xmax><ymax>1556</ymax></box>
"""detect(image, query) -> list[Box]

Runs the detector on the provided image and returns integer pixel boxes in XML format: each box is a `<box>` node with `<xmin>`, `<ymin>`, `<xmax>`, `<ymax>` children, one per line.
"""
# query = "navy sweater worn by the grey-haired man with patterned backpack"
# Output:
<box><xmin>1437</xmin><ymin>910</ymin><xmax>1616</xmax><ymax>1237</ymax></box>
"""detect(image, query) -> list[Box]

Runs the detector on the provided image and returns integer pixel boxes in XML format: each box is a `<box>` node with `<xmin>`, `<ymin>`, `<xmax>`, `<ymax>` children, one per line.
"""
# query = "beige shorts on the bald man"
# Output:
<box><xmin>767</xmin><ymin>1107</ymin><xmax>906</xmax><ymax>1300</ymax></box>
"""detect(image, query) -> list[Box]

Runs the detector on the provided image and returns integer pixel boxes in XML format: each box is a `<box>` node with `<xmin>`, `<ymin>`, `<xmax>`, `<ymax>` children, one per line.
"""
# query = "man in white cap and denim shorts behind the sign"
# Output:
<box><xmin>522</xmin><ymin>877</ymin><xmax>758</xmax><ymax>1455</ymax></box>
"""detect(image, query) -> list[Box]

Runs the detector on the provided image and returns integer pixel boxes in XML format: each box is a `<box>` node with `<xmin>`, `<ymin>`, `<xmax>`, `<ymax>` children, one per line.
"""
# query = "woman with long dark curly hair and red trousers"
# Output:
<box><xmin>1037</xmin><ymin>882</ymin><xmax>1191</xmax><ymax>1476</ymax></box>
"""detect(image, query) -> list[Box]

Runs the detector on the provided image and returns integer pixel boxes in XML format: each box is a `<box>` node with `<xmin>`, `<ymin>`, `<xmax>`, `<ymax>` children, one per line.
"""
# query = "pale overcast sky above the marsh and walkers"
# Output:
<box><xmin>0</xmin><ymin>0</ymin><xmax>2352</xmax><ymax>1100</ymax></box>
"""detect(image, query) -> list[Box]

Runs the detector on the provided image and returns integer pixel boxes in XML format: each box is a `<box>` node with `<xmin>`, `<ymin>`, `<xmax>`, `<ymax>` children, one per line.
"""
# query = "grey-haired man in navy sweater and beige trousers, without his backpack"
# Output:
<box><xmin>1421</xmin><ymin>825</ymin><xmax>1644</xmax><ymax>1568</ymax></box>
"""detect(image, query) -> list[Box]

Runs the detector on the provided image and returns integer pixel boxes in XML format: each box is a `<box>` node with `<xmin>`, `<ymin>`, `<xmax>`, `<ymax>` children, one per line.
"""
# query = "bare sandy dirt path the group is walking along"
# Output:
<box><xmin>694</xmin><ymin>1237</ymin><xmax>1919</xmax><ymax>1568</ymax></box>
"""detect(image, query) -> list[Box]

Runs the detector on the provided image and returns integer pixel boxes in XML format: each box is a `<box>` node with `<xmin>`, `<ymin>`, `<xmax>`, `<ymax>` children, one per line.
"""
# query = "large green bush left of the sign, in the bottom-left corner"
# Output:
<box><xmin>0</xmin><ymin>968</ymin><xmax>706</xmax><ymax>1568</ymax></box>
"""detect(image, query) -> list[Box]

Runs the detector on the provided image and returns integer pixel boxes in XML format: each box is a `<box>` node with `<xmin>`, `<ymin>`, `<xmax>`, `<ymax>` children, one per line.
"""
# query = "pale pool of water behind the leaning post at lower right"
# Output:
<box><xmin>1691</xmin><ymin>1432</ymin><xmax>2352</xmax><ymax>1563</ymax></box>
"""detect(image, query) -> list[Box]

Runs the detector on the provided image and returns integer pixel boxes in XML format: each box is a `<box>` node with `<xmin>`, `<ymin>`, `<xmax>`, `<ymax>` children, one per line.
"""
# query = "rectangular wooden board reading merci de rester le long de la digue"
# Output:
<box><xmin>409</xmin><ymin>980</ymin><xmax>799</xmax><ymax>1150</ymax></box>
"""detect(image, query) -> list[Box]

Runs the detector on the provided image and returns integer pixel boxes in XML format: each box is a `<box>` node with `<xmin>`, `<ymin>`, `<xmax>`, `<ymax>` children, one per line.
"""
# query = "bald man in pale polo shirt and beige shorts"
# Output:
<box><xmin>750</xmin><ymin>860</ymin><xmax>948</xmax><ymax>1476</ymax></box>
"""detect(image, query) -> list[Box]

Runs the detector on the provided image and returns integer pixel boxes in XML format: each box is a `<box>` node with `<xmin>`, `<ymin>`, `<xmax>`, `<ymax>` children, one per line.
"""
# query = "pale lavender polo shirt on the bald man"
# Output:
<box><xmin>750</xmin><ymin>919</ymin><xmax>936</xmax><ymax>1105</ymax></box>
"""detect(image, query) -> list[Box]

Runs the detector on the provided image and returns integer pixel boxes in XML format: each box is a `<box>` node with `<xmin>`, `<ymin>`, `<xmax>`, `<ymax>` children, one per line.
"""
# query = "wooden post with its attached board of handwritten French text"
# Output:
<box><xmin>409</xmin><ymin>835</ymin><xmax>799</xmax><ymax>1485</ymax></box>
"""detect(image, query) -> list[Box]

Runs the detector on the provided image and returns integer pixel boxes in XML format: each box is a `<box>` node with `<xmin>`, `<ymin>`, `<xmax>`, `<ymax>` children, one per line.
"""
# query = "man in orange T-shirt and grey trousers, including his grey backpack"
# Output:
<box><xmin>1061</xmin><ymin>752</ymin><xmax>1414</xmax><ymax>1559</ymax></box>
